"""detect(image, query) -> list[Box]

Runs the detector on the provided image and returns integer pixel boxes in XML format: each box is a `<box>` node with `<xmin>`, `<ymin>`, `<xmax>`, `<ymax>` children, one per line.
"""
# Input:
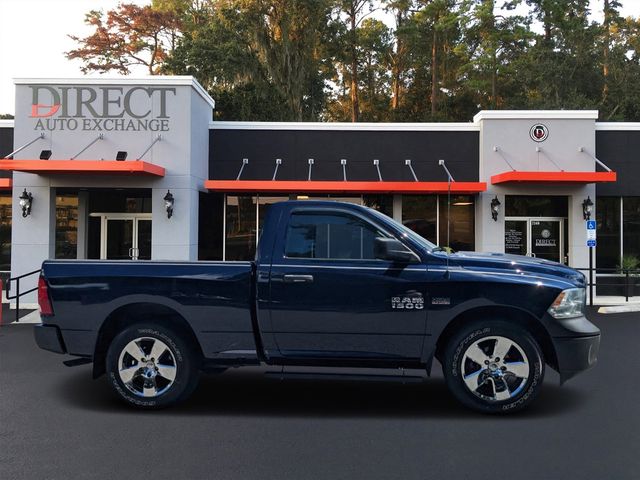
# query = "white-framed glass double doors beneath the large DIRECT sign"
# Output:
<box><xmin>100</xmin><ymin>214</ymin><xmax>151</xmax><ymax>260</ymax></box>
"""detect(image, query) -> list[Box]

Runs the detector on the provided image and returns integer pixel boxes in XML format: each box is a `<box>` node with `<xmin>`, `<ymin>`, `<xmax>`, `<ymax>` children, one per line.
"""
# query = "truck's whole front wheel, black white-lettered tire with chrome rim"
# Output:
<box><xmin>442</xmin><ymin>321</ymin><xmax>545</xmax><ymax>414</ymax></box>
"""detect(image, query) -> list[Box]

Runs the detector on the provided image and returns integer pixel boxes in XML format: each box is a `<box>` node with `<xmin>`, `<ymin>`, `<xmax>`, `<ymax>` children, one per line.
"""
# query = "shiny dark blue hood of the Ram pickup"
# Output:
<box><xmin>440</xmin><ymin>252</ymin><xmax>586</xmax><ymax>287</ymax></box>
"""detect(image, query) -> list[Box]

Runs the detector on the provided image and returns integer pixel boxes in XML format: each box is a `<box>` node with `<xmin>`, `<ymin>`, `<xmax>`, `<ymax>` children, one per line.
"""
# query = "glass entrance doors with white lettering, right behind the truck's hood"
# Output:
<box><xmin>504</xmin><ymin>217</ymin><xmax>568</xmax><ymax>263</ymax></box>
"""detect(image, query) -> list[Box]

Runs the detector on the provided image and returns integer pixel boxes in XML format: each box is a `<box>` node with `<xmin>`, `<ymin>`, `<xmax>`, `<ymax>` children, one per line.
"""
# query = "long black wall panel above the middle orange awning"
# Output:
<box><xmin>209</xmin><ymin>129</ymin><xmax>479</xmax><ymax>181</ymax></box>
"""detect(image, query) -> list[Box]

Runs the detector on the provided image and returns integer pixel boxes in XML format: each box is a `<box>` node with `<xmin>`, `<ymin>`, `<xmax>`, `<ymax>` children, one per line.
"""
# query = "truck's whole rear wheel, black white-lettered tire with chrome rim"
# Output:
<box><xmin>106</xmin><ymin>323</ymin><xmax>200</xmax><ymax>409</ymax></box>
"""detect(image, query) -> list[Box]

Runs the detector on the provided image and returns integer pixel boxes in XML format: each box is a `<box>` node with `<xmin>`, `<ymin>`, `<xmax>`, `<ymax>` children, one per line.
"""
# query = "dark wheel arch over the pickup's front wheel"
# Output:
<box><xmin>435</xmin><ymin>305</ymin><xmax>558</xmax><ymax>369</ymax></box>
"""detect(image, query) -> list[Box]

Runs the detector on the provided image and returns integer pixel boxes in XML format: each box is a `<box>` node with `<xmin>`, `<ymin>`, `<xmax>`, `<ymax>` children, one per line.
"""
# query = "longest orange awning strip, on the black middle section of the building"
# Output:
<box><xmin>204</xmin><ymin>180</ymin><xmax>487</xmax><ymax>193</ymax></box>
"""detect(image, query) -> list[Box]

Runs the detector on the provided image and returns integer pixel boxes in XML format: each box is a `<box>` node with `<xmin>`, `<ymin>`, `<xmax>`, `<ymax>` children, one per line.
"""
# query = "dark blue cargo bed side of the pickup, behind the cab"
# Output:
<box><xmin>43</xmin><ymin>260</ymin><xmax>256</xmax><ymax>359</ymax></box>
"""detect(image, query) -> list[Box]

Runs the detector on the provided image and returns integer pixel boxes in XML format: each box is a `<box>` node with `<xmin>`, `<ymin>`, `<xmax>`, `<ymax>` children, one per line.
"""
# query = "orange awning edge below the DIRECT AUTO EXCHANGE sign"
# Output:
<box><xmin>0</xmin><ymin>160</ymin><xmax>165</xmax><ymax>177</ymax></box>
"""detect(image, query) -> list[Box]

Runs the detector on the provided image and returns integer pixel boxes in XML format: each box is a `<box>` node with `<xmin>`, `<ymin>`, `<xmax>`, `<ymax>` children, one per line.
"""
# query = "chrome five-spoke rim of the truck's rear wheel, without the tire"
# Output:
<box><xmin>118</xmin><ymin>337</ymin><xmax>177</xmax><ymax>398</ymax></box>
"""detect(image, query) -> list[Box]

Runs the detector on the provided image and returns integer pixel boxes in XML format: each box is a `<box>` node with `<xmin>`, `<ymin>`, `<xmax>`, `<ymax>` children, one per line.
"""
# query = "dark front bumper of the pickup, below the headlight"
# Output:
<box><xmin>551</xmin><ymin>316</ymin><xmax>600</xmax><ymax>383</ymax></box>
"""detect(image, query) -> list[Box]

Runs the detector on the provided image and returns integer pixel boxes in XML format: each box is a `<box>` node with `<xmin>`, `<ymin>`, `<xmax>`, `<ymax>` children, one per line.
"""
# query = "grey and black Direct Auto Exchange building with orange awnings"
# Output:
<box><xmin>0</xmin><ymin>76</ymin><xmax>640</xmax><ymax>303</ymax></box>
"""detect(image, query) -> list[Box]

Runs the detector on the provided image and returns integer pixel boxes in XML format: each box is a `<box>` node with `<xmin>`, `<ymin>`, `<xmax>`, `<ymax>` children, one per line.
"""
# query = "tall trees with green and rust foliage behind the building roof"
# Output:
<box><xmin>68</xmin><ymin>0</ymin><xmax>640</xmax><ymax>122</ymax></box>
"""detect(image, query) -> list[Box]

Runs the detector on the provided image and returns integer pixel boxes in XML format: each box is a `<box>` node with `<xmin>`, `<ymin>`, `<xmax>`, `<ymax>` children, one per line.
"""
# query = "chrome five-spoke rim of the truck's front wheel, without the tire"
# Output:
<box><xmin>460</xmin><ymin>336</ymin><xmax>531</xmax><ymax>402</ymax></box>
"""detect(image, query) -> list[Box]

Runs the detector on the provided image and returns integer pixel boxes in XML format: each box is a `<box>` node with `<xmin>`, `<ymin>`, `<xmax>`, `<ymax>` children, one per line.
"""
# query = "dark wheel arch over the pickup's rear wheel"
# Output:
<box><xmin>93</xmin><ymin>302</ymin><xmax>204</xmax><ymax>378</ymax></box>
